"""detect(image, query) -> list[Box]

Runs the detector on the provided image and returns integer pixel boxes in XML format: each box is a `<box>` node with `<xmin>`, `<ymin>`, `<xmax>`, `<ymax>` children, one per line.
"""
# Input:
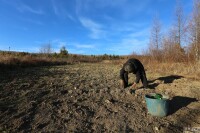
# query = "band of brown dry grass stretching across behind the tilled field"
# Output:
<box><xmin>0</xmin><ymin>52</ymin><xmax>200</xmax><ymax>79</ymax></box>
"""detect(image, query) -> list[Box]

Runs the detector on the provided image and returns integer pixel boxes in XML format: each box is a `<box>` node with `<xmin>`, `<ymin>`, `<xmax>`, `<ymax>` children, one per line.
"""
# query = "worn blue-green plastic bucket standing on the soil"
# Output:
<box><xmin>145</xmin><ymin>93</ymin><xmax>169</xmax><ymax>117</ymax></box>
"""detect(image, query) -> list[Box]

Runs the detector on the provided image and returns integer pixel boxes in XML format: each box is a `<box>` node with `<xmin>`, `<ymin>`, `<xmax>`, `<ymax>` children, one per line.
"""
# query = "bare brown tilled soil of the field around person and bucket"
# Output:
<box><xmin>0</xmin><ymin>63</ymin><xmax>200</xmax><ymax>133</ymax></box>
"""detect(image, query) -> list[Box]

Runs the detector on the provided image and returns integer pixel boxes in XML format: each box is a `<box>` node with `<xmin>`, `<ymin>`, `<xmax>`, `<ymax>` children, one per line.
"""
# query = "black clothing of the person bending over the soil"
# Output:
<box><xmin>120</xmin><ymin>58</ymin><xmax>147</xmax><ymax>88</ymax></box>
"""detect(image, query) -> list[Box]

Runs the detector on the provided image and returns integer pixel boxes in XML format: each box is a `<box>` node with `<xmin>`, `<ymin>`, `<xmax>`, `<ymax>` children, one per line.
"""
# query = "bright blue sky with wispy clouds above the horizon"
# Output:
<box><xmin>0</xmin><ymin>0</ymin><xmax>192</xmax><ymax>55</ymax></box>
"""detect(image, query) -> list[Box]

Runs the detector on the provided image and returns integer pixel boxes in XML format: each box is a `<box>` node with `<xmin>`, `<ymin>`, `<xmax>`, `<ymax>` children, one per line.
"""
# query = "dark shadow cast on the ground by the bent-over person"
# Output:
<box><xmin>148</xmin><ymin>75</ymin><xmax>184</xmax><ymax>89</ymax></box>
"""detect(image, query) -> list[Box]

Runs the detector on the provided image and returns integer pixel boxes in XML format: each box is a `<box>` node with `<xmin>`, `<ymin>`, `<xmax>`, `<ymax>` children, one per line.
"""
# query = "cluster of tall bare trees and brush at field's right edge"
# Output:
<box><xmin>146</xmin><ymin>0</ymin><xmax>200</xmax><ymax>62</ymax></box>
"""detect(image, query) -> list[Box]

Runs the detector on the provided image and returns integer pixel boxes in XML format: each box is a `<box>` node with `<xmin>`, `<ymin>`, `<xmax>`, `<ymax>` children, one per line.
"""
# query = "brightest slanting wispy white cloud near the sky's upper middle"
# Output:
<box><xmin>79</xmin><ymin>17</ymin><xmax>106</xmax><ymax>39</ymax></box>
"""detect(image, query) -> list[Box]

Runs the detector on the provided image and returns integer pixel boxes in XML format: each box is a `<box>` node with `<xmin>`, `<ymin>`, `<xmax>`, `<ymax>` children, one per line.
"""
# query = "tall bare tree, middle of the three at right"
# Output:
<box><xmin>159</xmin><ymin>0</ymin><xmax>186</xmax><ymax>61</ymax></box>
